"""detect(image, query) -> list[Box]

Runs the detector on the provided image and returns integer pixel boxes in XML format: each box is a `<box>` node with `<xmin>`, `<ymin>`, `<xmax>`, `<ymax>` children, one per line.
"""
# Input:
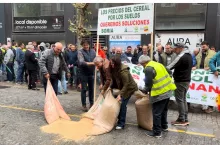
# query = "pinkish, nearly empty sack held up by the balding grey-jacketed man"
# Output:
<box><xmin>44</xmin><ymin>79</ymin><xmax>70</xmax><ymax>124</ymax></box>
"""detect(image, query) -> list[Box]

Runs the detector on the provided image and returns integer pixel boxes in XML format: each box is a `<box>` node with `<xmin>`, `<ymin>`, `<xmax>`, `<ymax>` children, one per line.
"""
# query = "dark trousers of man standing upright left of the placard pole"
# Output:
<box><xmin>80</xmin><ymin>75</ymin><xmax>94</xmax><ymax>106</ymax></box>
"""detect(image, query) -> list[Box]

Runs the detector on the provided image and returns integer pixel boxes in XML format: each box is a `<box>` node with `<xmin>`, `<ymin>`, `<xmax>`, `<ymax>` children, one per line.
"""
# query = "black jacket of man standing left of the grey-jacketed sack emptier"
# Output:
<box><xmin>25</xmin><ymin>50</ymin><xmax>38</xmax><ymax>70</ymax></box>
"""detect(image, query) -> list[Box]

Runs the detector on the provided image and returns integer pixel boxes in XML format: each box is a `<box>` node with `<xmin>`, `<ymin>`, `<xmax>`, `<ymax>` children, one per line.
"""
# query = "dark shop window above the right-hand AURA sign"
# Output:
<box><xmin>155</xmin><ymin>3</ymin><xmax>207</xmax><ymax>30</ymax></box>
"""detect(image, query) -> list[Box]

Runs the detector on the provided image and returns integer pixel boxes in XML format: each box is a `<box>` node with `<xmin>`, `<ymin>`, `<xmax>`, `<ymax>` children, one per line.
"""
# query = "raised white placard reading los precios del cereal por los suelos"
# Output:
<box><xmin>98</xmin><ymin>4</ymin><xmax>154</xmax><ymax>35</ymax></box>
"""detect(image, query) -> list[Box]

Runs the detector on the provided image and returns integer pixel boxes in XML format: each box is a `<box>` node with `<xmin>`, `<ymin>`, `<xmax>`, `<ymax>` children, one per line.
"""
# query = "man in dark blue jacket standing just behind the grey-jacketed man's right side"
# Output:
<box><xmin>65</xmin><ymin>45</ymin><xmax>78</xmax><ymax>87</ymax></box>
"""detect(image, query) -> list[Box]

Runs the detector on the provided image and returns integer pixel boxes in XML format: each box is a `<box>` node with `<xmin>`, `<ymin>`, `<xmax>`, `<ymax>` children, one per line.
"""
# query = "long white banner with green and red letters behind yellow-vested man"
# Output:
<box><xmin>123</xmin><ymin>62</ymin><xmax>220</xmax><ymax>106</ymax></box>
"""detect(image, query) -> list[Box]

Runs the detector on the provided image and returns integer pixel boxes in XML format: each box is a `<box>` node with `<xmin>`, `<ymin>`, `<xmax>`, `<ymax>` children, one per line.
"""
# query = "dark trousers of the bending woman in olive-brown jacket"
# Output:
<box><xmin>117</xmin><ymin>96</ymin><xmax>131</xmax><ymax>128</ymax></box>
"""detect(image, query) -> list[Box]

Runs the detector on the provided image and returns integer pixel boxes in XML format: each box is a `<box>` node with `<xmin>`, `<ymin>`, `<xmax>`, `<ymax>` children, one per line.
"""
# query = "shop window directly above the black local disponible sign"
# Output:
<box><xmin>13</xmin><ymin>3</ymin><xmax>64</xmax><ymax>17</ymax></box>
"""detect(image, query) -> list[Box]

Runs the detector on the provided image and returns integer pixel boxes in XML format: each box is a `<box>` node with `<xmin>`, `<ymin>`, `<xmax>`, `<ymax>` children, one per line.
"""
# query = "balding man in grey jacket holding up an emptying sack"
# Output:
<box><xmin>39</xmin><ymin>42</ymin><xmax>70</xmax><ymax>95</ymax></box>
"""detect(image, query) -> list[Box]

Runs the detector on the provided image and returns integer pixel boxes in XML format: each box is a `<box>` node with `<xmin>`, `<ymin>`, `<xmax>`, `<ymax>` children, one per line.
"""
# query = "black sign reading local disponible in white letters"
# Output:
<box><xmin>14</xmin><ymin>16</ymin><xmax>64</xmax><ymax>32</ymax></box>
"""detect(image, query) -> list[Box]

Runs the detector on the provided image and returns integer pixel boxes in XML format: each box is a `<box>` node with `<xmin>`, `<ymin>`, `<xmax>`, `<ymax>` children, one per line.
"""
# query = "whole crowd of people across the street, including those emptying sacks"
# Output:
<box><xmin>0</xmin><ymin>40</ymin><xmax>220</xmax><ymax>137</ymax></box>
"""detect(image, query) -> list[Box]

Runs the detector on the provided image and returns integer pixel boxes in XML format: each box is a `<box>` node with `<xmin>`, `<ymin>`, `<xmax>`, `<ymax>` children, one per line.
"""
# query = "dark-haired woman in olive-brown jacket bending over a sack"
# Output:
<box><xmin>110</xmin><ymin>56</ymin><xmax>138</xmax><ymax>130</ymax></box>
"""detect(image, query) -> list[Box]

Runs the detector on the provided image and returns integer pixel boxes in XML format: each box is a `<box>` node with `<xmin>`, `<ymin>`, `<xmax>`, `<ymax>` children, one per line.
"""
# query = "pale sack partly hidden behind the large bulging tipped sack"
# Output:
<box><xmin>82</xmin><ymin>94</ymin><xmax>104</xmax><ymax>119</ymax></box>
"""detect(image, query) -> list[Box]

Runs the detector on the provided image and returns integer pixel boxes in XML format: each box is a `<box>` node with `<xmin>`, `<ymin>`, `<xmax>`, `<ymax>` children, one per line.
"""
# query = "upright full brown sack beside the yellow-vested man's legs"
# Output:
<box><xmin>135</xmin><ymin>96</ymin><xmax>153</xmax><ymax>130</ymax></box>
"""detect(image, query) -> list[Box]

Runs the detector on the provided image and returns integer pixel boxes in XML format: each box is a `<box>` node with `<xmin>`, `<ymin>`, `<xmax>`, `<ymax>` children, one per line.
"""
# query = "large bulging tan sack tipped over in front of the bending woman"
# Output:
<box><xmin>88</xmin><ymin>90</ymin><xmax>120</xmax><ymax>135</ymax></box>
